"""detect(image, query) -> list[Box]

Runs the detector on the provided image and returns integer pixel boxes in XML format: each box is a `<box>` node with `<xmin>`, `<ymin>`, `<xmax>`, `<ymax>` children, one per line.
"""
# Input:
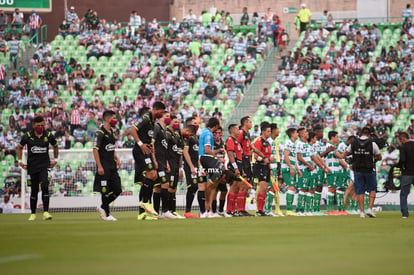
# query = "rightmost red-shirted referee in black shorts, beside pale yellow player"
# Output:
<box><xmin>253</xmin><ymin>122</ymin><xmax>272</xmax><ymax>217</ymax></box>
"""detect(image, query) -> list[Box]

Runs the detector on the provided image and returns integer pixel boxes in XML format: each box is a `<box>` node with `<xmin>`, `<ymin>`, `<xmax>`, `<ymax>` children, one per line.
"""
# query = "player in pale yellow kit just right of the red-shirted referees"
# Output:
<box><xmin>264</xmin><ymin>123</ymin><xmax>284</xmax><ymax>217</ymax></box>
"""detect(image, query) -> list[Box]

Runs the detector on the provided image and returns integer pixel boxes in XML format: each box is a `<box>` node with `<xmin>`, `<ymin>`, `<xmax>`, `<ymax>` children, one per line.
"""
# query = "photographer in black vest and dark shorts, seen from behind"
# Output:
<box><xmin>343</xmin><ymin>127</ymin><xmax>382</xmax><ymax>218</ymax></box>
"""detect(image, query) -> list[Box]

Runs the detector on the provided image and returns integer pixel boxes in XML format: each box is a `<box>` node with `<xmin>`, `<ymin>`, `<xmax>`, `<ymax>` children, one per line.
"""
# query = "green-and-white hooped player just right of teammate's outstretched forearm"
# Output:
<box><xmin>325</xmin><ymin>131</ymin><xmax>343</xmax><ymax>215</ymax></box>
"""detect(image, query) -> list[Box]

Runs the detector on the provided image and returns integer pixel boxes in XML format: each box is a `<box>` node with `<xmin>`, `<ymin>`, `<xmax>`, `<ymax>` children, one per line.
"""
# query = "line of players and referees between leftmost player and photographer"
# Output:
<box><xmin>94</xmin><ymin>102</ymin><xmax>362</xmax><ymax>221</ymax></box>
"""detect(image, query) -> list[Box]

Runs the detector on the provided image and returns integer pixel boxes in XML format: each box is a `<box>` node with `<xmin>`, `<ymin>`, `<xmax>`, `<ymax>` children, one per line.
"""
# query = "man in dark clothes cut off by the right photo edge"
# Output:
<box><xmin>397</xmin><ymin>132</ymin><xmax>414</xmax><ymax>219</ymax></box>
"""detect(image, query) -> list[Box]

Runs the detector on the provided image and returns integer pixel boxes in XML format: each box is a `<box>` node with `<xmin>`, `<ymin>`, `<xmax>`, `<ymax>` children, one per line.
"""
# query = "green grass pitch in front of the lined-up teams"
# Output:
<box><xmin>0</xmin><ymin>212</ymin><xmax>414</xmax><ymax>275</ymax></box>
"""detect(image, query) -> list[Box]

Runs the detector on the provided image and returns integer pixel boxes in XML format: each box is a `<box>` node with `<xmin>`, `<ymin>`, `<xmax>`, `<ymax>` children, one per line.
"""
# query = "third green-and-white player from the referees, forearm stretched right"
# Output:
<box><xmin>305</xmin><ymin>132</ymin><xmax>331</xmax><ymax>216</ymax></box>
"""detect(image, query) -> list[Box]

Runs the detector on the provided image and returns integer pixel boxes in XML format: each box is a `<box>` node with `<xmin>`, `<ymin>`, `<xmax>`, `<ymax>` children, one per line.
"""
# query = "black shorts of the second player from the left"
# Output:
<box><xmin>93</xmin><ymin>169</ymin><xmax>122</xmax><ymax>194</ymax></box>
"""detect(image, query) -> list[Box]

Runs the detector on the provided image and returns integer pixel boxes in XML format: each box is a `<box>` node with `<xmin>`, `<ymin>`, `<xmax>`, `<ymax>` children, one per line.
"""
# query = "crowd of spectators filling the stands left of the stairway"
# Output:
<box><xmin>0</xmin><ymin>7</ymin><xmax>280</xmax><ymax>198</ymax></box>
